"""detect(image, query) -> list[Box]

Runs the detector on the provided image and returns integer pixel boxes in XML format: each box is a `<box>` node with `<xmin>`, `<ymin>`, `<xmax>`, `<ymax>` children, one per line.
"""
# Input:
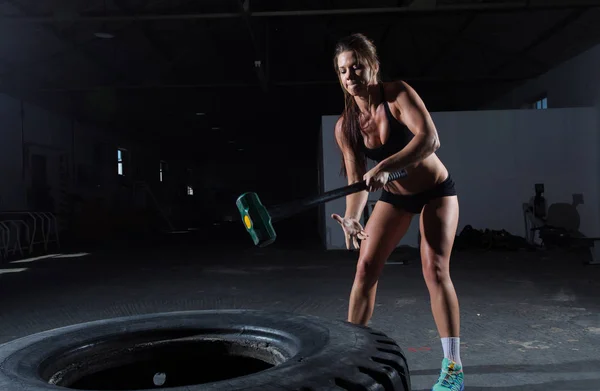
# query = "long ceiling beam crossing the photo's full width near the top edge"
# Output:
<box><xmin>0</xmin><ymin>0</ymin><xmax>600</xmax><ymax>23</ymax></box>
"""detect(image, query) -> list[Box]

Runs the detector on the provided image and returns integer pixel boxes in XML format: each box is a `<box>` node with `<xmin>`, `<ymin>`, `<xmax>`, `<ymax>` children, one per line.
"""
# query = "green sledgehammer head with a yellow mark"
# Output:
<box><xmin>235</xmin><ymin>193</ymin><xmax>277</xmax><ymax>247</ymax></box>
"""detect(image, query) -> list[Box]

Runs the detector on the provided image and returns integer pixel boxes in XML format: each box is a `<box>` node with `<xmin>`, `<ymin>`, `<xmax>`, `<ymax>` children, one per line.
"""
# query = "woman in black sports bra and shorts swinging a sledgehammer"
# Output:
<box><xmin>332</xmin><ymin>34</ymin><xmax>464</xmax><ymax>391</ymax></box>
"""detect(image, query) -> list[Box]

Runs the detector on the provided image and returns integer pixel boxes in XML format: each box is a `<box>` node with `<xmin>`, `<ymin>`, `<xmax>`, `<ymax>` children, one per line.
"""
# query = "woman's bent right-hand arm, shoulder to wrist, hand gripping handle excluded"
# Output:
<box><xmin>377</xmin><ymin>82</ymin><xmax>440</xmax><ymax>172</ymax></box>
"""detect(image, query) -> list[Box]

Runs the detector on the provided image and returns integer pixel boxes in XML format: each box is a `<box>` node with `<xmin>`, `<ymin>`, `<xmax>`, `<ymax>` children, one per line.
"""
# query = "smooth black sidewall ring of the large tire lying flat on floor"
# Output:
<box><xmin>0</xmin><ymin>310</ymin><xmax>410</xmax><ymax>391</ymax></box>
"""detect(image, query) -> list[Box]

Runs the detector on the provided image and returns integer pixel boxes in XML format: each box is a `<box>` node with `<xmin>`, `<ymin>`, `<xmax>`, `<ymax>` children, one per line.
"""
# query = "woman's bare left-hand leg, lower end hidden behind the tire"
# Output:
<box><xmin>348</xmin><ymin>201</ymin><xmax>413</xmax><ymax>325</ymax></box>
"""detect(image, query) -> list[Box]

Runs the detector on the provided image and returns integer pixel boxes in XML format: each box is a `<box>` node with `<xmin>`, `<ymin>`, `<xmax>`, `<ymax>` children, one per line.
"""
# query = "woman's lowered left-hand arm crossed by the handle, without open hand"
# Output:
<box><xmin>335</xmin><ymin>117</ymin><xmax>369</xmax><ymax>220</ymax></box>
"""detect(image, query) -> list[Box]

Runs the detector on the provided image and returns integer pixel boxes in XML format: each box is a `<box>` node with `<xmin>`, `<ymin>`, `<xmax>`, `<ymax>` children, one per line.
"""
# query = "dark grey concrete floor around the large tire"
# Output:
<box><xmin>0</xmin><ymin>234</ymin><xmax>600</xmax><ymax>391</ymax></box>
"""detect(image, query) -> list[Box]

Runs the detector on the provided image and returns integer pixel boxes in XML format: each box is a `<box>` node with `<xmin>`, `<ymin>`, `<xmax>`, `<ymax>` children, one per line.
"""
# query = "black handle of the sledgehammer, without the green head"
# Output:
<box><xmin>269</xmin><ymin>170</ymin><xmax>408</xmax><ymax>222</ymax></box>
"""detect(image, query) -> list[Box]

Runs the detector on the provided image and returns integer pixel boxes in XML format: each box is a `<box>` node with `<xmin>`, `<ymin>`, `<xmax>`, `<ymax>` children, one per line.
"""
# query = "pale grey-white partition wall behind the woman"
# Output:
<box><xmin>322</xmin><ymin>108</ymin><xmax>600</xmax><ymax>249</ymax></box>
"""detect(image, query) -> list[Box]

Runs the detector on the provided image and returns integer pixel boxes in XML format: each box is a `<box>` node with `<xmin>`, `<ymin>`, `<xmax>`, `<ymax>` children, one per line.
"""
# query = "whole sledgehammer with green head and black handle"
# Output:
<box><xmin>235</xmin><ymin>170</ymin><xmax>407</xmax><ymax>247</ymax></box>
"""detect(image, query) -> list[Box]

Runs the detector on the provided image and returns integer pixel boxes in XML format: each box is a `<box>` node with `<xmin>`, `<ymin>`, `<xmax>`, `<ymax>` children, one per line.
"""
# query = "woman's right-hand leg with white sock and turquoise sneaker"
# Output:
<box><xmin>420</xmin><ymin>196</ymin><xmax>463</xmax><ymax>391</ymax></box>
